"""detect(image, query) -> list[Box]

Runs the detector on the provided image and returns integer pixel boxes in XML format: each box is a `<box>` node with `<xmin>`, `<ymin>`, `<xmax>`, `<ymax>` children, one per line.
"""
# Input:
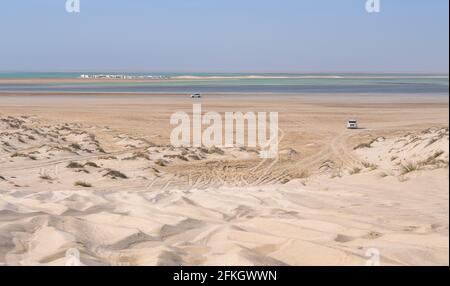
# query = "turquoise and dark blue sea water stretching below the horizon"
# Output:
<box><xmin>0</xmin><ymin>72</ymin><xmax>449</xmax><ymax>94</ymax></box>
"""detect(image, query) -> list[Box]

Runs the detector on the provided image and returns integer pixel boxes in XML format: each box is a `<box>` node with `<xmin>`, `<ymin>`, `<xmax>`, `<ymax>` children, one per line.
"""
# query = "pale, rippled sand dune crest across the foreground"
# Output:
<box><xmin>0</xmin><ymin>170</ymin><xmax>449</xmax><ymax>265</ymax></box>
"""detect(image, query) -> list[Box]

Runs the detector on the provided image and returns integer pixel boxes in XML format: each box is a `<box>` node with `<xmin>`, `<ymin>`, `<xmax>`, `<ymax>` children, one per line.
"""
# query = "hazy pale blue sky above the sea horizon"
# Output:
<box><xmin>0</xmin><ymin>0</ymin><xmax>449</xmax><ymax>73</ymax></box>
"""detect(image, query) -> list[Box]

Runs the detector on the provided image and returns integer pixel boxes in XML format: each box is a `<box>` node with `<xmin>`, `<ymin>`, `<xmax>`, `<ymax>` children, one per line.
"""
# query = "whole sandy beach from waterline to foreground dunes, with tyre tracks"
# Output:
<box><xmin>0</xmin><ymin>93</ymin><xmax>449</xmax><ymax>266</ymax></box>
